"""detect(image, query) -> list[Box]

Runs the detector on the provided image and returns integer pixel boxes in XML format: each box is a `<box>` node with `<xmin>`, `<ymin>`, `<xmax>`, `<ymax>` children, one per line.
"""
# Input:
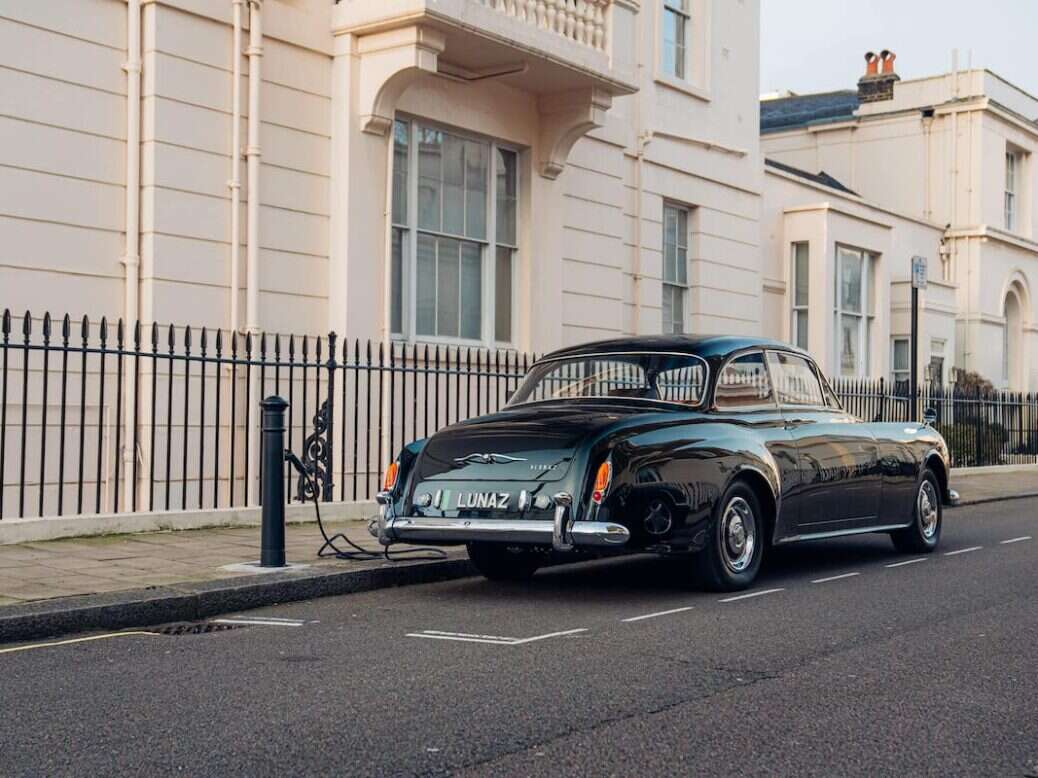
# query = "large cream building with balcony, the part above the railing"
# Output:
<box><xmin>0</xmin><ymin>0</ymin><xmax>762</xmax><ymax>352</ymax></box>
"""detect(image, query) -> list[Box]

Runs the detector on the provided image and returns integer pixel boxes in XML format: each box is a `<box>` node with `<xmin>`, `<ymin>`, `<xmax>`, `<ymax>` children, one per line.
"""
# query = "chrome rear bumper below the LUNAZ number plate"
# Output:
<box><xmin>371</xmin><ymin>493</ymin><xmax>631</xmax><ymax>551</ymax></box>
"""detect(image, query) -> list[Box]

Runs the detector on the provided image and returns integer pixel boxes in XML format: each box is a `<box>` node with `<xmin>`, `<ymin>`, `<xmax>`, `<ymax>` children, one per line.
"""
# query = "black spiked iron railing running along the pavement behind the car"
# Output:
<box><xmin>0</xmin><ymin>311</ymin><xmax>1038</xmax><ymax>519</ymax></box>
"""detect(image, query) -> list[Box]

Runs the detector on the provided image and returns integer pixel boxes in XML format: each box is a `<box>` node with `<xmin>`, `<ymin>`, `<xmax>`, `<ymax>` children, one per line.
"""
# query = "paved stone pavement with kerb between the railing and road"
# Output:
<box><xmin>0</xmin><ymin>468</ymin><xmax>1038</xmax><ymax>643</ymax></box>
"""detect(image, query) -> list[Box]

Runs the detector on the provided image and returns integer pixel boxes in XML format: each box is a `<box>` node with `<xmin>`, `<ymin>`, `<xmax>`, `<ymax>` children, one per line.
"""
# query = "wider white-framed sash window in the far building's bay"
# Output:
<box><xmin>834</xmin><ymin>246</ymin><xmax>875</xmax><ymax>377</ymax></box>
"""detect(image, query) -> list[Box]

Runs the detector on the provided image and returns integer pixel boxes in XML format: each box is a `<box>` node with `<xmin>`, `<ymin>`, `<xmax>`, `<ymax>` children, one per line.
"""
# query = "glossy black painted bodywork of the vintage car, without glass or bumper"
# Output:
<box><xmin>384</xmin><ymin>336</ymin><xmax>948</xmax><ymax>552</ymax></box>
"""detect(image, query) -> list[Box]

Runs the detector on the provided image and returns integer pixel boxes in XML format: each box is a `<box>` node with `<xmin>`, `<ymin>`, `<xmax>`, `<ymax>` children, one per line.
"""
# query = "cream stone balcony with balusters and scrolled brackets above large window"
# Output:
<box><xmin>332</xmin><ymin>0</ymin><xmax>639</xmax><ymax>177</ymax></box>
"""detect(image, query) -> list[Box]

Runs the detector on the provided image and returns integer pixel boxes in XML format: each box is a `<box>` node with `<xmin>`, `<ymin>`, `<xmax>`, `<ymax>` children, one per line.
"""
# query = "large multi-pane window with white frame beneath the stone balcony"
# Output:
<box><xmin>389</xmin><ymin>120</ymin><xmax>519</xmax><ymax>345</ymax></box>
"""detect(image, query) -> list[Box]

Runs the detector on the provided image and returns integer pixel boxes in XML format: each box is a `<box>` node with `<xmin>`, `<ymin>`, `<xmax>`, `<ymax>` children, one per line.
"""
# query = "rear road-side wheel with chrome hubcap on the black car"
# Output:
<box><xmin>696</xmin><ymin>483</ymin><xmax>766</xmax><ymax>591</ymax></box>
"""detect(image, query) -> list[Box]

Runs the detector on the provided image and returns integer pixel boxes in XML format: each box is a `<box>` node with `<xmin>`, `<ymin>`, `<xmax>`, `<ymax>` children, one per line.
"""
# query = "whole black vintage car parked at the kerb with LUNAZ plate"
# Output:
<box><xmin>373</xmin><ymin>336</ymin><xmax>952</xmax><ymax>590</ymax></box>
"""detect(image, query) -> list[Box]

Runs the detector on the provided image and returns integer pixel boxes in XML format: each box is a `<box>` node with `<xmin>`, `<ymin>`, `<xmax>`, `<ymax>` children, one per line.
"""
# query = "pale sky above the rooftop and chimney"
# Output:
<box><xmin>759</xmin><ymin>0</ymin><xmax>1038</xmax><ymax>95</ymax></box>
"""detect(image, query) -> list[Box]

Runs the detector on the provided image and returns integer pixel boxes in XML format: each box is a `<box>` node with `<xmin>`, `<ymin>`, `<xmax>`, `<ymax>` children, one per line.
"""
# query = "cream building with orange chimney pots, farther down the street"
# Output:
<box><xmin>762</xmin><ymin>56</ymin><xmax>1038</xmax><ymax>389</ymax></box>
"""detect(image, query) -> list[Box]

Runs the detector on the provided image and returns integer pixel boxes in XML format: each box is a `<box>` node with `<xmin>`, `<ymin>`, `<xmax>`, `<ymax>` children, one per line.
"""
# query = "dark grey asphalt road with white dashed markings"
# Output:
<box><xmin>0</xmin><ymin>500</ymin><xmax>1038</xmax><ymax>776</ymax></box>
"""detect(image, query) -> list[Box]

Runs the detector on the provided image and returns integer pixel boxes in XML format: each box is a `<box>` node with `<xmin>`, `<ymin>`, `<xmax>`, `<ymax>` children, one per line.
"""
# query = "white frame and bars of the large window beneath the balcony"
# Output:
<box><xmin>386</xmin><ymin>114</ymin><xmax>522</xmax><ymax>349</ymax></box>
